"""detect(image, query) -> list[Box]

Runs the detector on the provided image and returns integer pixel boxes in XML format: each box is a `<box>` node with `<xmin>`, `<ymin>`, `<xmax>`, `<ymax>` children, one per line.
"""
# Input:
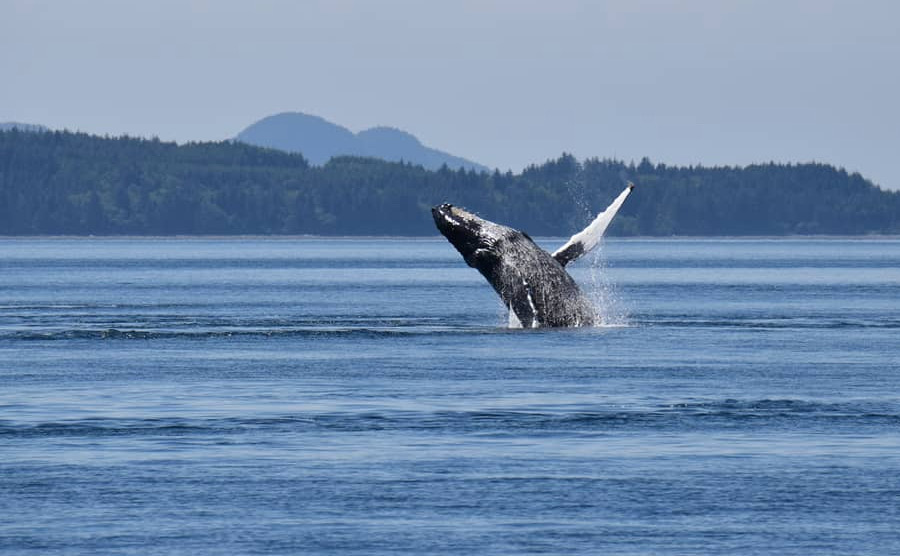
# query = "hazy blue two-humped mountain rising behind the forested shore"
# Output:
<box><xmin>235</xmin><ymin>112</ymin><xmax>489</xmax><ymax>172</ymax></box>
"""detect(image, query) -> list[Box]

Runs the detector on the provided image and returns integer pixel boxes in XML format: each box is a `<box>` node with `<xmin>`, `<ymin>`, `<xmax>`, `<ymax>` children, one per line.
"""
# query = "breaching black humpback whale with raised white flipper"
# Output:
<box><xmin>431</xmin><ymin>182</ymin><xmax>634</xmax><ymax>328</ymax></box>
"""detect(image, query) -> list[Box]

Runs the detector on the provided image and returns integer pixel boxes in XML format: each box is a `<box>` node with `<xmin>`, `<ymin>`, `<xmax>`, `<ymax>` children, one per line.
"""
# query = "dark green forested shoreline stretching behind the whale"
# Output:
<box><xmin>0</xmin><ymin>130</ymin><xmax>900</xmax><ymax>236</ymax></box>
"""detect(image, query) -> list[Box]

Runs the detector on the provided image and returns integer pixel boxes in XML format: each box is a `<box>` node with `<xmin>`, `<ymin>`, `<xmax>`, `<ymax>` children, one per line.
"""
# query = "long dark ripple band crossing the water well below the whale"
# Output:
<box><xmin>0</xmin><ymin>398</ymin><xmax>900</xmax><ymax>439</ymax></box>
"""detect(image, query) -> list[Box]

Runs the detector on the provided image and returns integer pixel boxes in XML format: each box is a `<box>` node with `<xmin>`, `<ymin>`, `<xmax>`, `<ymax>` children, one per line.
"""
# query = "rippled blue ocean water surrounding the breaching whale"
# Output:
<box><xmin>0</xmin><ymin>238</ymin><xmax>900</xmax><ymax>555</ymax></box>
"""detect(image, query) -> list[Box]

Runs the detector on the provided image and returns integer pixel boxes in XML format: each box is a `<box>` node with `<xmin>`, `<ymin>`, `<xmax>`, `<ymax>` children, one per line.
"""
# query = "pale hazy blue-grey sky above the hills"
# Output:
<box><xmin>0</xmin><ymin>0</ymin><xmax>900</xmax><ymax>188</ymax></box>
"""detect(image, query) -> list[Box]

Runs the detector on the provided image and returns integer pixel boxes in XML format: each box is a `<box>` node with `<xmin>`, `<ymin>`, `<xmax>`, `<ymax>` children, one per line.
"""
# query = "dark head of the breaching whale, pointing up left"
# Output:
<box><xmin>431</xmin><ymin>203</ymin><xmax>506</xmax><ymax>270</ymax></box>
